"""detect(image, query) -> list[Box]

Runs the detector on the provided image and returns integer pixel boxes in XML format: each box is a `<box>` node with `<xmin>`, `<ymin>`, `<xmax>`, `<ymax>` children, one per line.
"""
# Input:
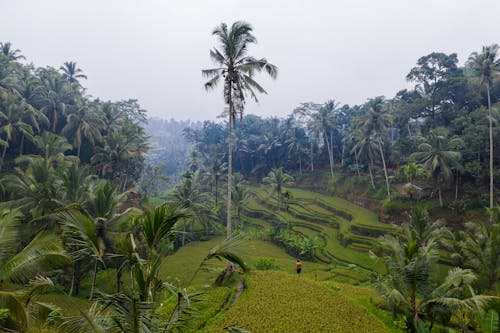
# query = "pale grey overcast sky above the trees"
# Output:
<box><xmin>0</xmin><ymin>0</ymin><xmax>500</xmax><ymax>120</ymax></box>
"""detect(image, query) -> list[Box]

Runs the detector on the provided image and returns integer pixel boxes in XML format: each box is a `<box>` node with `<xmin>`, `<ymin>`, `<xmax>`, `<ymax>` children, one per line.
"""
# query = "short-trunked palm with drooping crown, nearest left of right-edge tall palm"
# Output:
<box><xmin>410</xmin><ymin>128</ymin><xmax>462</xmax><ymax>207</ymax></box>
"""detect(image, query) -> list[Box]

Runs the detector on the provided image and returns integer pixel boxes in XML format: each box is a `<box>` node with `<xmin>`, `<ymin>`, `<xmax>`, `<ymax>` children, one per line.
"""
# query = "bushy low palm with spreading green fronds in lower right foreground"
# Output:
<box><xmin>378</xmin><ymin>211</ymin><xmax>494</xmax><ymax>333</ymax></box>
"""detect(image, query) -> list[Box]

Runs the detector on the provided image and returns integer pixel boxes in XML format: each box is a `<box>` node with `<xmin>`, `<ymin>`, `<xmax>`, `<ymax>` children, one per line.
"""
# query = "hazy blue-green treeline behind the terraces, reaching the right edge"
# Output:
<box><xmin>185</xmin><ymin>45</ymin><xmax>500</xmax><ymax>207</ymax></box>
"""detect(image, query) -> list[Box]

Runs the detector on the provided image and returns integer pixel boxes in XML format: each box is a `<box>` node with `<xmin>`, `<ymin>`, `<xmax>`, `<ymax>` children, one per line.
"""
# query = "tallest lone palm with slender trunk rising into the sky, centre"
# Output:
<box><xmin>202</xmin><ymin>21</ymin><xmax>278</xmax><ymax>238</ymax></box>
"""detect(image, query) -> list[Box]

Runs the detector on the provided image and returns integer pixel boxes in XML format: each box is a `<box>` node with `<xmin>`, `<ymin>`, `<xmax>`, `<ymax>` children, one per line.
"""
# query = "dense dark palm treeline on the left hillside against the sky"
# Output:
<box><xmin>0</xmin><ymin>43</ymin><xmax>148</xmax><ymax>191</ymax></box>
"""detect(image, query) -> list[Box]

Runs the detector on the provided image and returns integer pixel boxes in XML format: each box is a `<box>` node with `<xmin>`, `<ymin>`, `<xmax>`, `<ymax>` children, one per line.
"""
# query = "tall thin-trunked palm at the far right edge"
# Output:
<box><xmin>468</xmin><ymin>44</ymin><xmax>500</xmax><ymax>208</ymax></box>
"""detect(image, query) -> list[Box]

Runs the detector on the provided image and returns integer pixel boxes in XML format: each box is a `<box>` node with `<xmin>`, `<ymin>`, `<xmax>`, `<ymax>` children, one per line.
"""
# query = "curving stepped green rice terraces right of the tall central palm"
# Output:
<box><xmin>243</xmin><ymin>187</ymin><xmax>393</xmax><ymax>281</ymax></box>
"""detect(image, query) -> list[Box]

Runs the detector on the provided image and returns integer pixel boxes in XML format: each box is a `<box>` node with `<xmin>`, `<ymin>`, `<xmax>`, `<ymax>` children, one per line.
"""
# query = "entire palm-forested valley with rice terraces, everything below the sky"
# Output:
<box><xmin>0</xmin><ymin>22</ymin><xmax>500</xmax><ymax>333</ymax></box>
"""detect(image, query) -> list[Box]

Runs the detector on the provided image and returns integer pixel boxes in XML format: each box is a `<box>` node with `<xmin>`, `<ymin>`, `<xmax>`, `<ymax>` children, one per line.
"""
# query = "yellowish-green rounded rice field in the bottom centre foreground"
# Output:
<box><xmin>203</xmin><ymin>271</ymin><xmax>390</xmax><ymax>333</ymax></box>
